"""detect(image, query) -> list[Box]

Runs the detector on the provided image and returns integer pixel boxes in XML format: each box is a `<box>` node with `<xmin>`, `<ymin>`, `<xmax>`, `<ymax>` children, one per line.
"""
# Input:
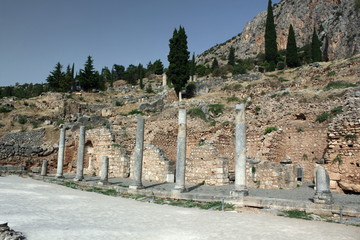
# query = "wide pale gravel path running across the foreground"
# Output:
<box><xmin>0</xmin><ymin>176</ymin><xmax>360</xmax><ymax>240</ymax></box>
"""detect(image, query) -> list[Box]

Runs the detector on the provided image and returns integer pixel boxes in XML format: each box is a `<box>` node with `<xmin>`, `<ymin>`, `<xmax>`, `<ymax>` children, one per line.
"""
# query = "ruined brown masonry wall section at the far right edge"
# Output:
<box><xmin>324</xmin><ymin>88</ymin><xmax>360</xmax><ymax>192</ymax></box>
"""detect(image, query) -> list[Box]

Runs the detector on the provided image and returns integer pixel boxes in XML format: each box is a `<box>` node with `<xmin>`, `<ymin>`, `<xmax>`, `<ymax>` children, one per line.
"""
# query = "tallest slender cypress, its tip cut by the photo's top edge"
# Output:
<box><xmin>265</xmin><ymin>0</ymin><xmax>278</xmax><ymax>70</ymax></box>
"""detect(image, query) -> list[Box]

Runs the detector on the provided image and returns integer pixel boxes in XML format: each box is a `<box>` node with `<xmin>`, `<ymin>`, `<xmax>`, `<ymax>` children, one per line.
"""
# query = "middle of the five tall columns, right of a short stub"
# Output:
<box><xmin>129</xmin><ymin>116</ymin><xmax>145</xmax><ymax>189</ymax></box>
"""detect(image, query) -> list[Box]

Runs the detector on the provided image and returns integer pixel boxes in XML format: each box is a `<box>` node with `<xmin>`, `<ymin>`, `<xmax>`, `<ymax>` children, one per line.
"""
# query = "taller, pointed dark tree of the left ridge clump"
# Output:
<box><xmin>77</xmin><ymin>56</ymin><xmax>105</xmax><ymax>91</ymax></box>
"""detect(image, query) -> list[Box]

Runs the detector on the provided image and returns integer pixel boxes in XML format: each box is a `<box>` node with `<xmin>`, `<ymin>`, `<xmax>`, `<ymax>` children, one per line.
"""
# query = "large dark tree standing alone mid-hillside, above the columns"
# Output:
<box><xmin>167</xmin><ymin>26</ymin><xmax>189</xmax><ymax>94</ymax></box>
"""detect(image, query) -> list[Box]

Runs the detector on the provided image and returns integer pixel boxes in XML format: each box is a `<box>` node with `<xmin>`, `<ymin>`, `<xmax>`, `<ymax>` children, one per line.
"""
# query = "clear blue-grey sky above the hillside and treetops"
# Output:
<box><xmin>0</xmin><ymin>0</ymin><xmax>279</xmax><ymax>86</ymax></box>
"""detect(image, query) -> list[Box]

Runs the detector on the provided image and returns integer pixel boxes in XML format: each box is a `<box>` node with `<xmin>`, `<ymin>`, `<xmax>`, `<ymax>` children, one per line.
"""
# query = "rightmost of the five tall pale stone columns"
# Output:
<box><xmin>230</xmin><ymin>103</ymin><xmax>248</xmax><ymax>197</ymax></box>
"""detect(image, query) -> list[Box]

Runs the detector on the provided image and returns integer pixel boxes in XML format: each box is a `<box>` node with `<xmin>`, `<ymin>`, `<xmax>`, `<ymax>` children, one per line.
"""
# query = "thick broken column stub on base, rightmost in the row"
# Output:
<box><xmin>314</xmin><ymin>166</ymin><xmax>333</xmax><ymax>204</ymax></box>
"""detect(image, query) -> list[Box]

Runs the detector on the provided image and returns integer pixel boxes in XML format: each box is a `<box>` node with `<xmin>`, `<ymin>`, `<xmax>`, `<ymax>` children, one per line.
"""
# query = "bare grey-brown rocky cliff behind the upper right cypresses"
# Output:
<box><xmin>197</xmin><ymin>0</ymin><xmax>360</xmax><ymax>64</ymax></box>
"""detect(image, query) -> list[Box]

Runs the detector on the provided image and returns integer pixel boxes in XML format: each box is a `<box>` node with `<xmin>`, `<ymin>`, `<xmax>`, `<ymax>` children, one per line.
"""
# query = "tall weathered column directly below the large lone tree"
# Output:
<box><xmin>173</xmin><ymin>108</ymin><xmax>186</xmax><ymax>193</ymax></box>
